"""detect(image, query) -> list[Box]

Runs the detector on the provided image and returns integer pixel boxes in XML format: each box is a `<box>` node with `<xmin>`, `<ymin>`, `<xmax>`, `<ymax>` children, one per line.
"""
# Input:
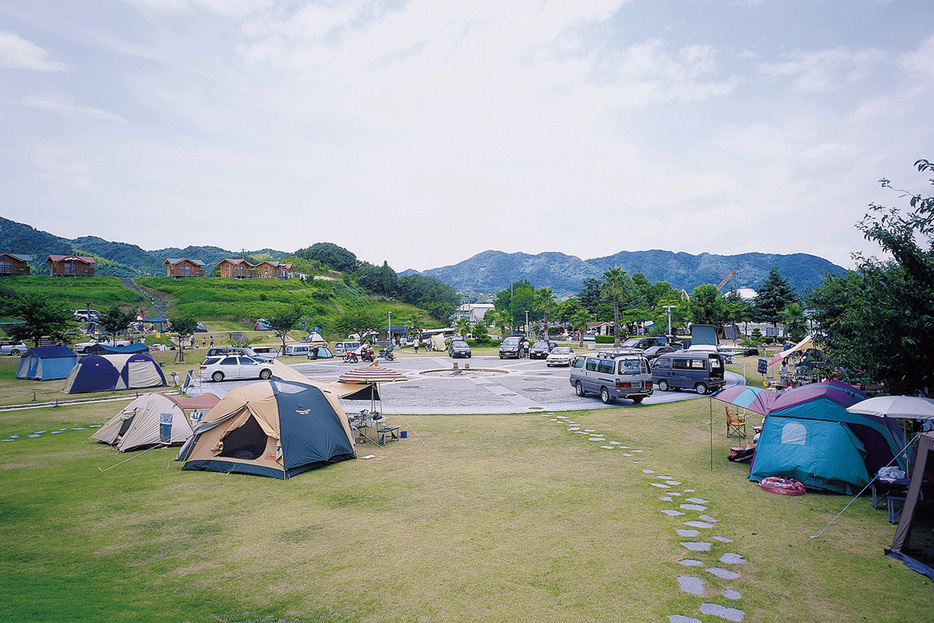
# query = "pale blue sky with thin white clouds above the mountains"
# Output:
<box><xmin>0</xmin><ymin>0</ymin><xmax>934</xmax><ymax>271</ymax></box>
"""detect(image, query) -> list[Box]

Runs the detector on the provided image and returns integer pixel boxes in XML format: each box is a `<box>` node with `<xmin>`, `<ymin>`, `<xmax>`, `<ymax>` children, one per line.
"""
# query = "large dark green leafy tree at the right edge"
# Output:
<box><xmin>808</xmin><ymin>160</ymin><xmax>934</xmax><ymax>396</ymax></box>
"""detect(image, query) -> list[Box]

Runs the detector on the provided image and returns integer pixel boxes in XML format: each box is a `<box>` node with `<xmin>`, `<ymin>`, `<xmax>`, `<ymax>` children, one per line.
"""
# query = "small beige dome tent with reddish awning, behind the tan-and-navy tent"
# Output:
<box><xmin>91</xmin><ymin>393</ymin><xmax>220</xmax><ymax>452</ymax></box>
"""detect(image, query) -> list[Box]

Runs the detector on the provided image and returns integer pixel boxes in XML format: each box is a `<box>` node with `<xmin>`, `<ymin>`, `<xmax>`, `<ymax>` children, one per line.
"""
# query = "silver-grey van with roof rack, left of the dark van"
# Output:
<box><xmin>570</xmin><ymin>353</ymin><xmax>652</xmax><ymax>404</ymax></box>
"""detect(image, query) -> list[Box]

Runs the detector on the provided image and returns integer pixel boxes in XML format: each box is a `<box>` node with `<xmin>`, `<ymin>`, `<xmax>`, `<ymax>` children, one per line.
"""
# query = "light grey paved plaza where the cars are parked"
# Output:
<box><xmin>192</xmin><ymin>354</ymin><xmax>742</xmax><ymax>415</ymax></box>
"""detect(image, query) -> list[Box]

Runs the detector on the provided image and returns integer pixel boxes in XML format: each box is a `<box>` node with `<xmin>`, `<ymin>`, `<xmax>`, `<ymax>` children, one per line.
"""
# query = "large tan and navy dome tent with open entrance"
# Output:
<box><xmin>178</xmin><ymin>372</ymin><xmax>356</xmax><ymax>479</ymax></box>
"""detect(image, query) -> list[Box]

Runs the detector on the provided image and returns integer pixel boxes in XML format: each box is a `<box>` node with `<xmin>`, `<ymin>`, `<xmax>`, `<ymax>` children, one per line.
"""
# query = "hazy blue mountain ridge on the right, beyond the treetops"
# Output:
<box><xmin>401</xmin><ymin>249</ymin><xmax>846</xmax><ymax>298</ymax></box>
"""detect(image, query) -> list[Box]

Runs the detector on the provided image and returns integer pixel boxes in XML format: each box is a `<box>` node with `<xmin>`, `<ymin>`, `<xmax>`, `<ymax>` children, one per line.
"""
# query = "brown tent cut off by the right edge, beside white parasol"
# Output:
<box><xmin>885</xmin><ymin>431</ymin><xmax>934</xmax><ymax>580</ymax></box>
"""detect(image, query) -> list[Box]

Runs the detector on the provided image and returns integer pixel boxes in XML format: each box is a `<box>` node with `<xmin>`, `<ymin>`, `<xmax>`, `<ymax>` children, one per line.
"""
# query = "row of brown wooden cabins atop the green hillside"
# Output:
<box><xmin>0</xmin><ymin>253</ymin><xmax>295</xmax><ymax>279</ymax></box>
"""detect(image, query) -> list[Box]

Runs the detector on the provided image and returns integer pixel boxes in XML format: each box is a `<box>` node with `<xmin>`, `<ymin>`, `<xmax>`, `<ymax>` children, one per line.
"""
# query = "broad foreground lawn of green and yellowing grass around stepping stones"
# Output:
<box><xmin>0</xmin><ymin>389</ymin><xmax>932</xmax><ymax>622</ymax></box>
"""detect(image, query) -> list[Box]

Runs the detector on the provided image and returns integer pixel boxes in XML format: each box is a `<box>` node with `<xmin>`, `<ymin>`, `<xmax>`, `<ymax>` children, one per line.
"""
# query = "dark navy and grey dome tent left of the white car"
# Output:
<box><xmin>63</xmin><ymin>353</ymin><xmax>168</xmax><ymax>394</ymax></box>
